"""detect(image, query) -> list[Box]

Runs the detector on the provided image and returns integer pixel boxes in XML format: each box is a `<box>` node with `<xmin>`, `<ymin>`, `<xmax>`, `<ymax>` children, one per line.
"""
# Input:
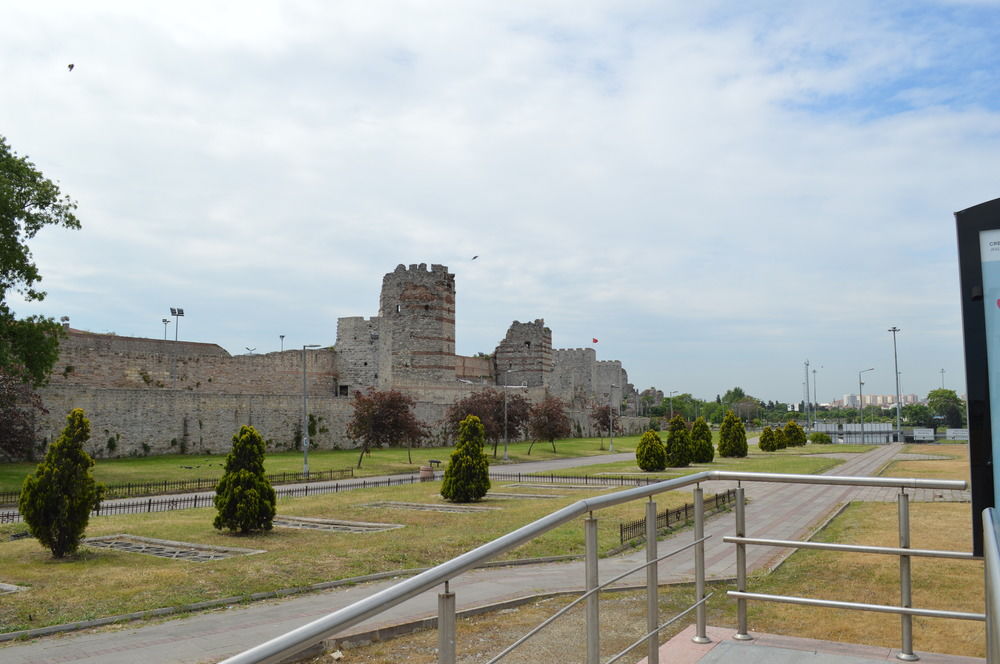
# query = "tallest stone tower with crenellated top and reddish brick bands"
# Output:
<box><xmin>379</xmin><ymin>263</ymin><xmax>455</xmax><ymax>386</ymax></box>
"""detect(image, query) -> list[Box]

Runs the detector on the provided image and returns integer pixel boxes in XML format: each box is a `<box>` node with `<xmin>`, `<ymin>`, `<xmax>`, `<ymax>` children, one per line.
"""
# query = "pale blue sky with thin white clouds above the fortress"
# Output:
<box><xmin>0</xmin><ymin>0</ymin><xmax>1000</xmax><ymax>402</ymax></box>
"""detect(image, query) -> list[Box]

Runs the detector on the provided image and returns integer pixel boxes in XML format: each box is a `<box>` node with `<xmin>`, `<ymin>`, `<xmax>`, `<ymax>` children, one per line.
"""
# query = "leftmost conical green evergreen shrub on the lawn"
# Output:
<box><xmin>18</xmin><ymin>408</ymin><xmax>104</xmax><ymax>558</ymax></box>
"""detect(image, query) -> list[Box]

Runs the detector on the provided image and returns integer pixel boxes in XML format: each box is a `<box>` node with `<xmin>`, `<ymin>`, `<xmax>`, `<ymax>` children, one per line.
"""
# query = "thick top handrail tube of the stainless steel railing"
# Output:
<box><xmin>220</xmin><ymin>470</ymin><xmax>967</xmax><ymax>664</ymax></box>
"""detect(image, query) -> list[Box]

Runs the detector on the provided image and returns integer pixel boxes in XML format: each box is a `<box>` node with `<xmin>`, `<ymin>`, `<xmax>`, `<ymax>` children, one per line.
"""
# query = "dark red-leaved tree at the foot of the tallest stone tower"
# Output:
<box><xmin>347</xmin><ymin>388</ymin><xmax>428</xmax><ymax>468</ymax></box>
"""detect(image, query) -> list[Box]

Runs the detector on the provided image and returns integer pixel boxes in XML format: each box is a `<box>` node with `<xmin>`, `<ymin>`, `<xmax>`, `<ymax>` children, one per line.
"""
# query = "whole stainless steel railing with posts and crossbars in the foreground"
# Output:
<box><xmin>221</xmin><ymin>471</ymin><xmax>968</xmax><ymax>664</ymax></box>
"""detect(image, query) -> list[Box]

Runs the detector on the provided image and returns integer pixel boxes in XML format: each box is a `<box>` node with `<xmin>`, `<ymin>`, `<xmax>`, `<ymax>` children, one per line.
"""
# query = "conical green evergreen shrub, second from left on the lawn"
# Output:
<box><xmin>212</xmin><ymin>425</ymin><xmax>277</xmax><ymax>533</ymax></box>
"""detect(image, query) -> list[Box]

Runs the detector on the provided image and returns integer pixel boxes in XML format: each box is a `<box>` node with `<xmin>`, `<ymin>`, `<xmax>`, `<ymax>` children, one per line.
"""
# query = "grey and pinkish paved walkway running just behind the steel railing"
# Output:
<box><xmin>0</xmin><ymin>444</ymin><xmax>964</xmax><ymax>664</ymax></box>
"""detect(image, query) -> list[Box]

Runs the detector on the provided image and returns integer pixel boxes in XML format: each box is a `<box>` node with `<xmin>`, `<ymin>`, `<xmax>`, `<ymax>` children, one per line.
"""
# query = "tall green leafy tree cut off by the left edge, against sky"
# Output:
<box><xmin>0</xmin><ymin>136</ymin><xmax>80</xmax><ymax>390</ymax></box>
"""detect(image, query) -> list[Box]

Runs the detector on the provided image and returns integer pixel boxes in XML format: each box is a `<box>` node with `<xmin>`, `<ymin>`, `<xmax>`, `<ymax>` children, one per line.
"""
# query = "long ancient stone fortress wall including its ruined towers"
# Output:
<box><xmin>37</xmin><ymin>264</ymin><xmax>640</xmax><ymax>456</ymax></box>
